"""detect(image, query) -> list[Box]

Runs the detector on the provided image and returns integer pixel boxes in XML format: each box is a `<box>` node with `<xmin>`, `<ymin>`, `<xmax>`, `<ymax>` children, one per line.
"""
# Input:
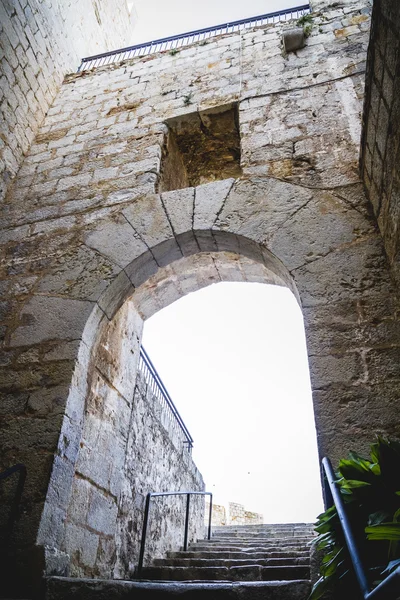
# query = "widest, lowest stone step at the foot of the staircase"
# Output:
<box><xmin>45</xmin><ymin>577</ymin><xmax>311</xmax><ymax>600</ymax></box>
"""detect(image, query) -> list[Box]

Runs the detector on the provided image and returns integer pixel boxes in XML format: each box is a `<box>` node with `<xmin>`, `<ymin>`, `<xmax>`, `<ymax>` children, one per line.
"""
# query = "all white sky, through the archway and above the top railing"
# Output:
<box><xmin>132</xmin><ymin>0</ymin><xmax>322</xmax><ymax>522</ymax></box>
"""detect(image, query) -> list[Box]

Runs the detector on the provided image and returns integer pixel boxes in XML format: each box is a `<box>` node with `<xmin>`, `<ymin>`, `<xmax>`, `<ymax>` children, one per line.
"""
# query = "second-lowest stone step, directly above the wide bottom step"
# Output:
<box><xmin>141</xmin><ymin>565</ymin><xmax>310</xmax><ymax>581</ymax></box>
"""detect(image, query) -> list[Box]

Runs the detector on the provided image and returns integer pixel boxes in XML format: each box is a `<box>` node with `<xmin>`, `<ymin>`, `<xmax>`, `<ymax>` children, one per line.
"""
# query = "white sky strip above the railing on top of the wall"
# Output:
<box><xmin>128</xmin><ymin>0</ymin><xmax>307</xmax><ymax>44</ymax></box>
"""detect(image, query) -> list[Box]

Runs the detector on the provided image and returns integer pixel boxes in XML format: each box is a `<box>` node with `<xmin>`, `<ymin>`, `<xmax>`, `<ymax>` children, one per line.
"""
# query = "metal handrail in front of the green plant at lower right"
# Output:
<box><xmin>322</xmin><ymin>457</ymin><xmax>400</xmax><ymax>600</ymax></box>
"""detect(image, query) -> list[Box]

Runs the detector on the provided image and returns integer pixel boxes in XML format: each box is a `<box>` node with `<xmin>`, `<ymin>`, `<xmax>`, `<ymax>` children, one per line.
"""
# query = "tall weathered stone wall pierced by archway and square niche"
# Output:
<box><xmin>0</xmin><ymin>0</ymin><xmax>400</xmax><ymax>592</ymax></box>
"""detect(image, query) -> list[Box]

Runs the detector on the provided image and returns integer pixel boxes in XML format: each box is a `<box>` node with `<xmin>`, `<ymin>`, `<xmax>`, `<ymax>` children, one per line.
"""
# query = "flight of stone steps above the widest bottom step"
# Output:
<box><xmin>141</xmin><ymin>524</ymin><xmax>314</xmax><ymax>581</ymax></box>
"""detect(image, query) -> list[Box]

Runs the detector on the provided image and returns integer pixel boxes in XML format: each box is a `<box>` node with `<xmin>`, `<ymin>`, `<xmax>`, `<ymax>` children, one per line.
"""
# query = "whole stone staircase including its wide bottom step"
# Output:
<box><xmin>46</xmin><ymin>523</ymin><xmax>314</xmax><ymax>600</ymax></box>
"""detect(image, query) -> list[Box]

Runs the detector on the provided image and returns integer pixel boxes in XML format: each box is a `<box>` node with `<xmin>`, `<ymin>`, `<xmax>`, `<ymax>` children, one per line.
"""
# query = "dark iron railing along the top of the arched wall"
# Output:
<box><xmin>78</xmin><ymin>4</ymin><xmax>310</xmax><ymax>73</ymax></box>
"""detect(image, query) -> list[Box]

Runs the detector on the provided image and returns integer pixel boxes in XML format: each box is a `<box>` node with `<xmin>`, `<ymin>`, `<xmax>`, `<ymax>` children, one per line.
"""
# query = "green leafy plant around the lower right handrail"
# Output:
<box><xmin>309</xmin><ymin>437</ymin><xmax>400</xmax><ymax>600</ymax></box>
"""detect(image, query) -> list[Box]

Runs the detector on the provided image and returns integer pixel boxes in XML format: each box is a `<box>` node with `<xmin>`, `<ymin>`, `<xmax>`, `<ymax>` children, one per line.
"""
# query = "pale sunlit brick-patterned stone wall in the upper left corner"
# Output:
<box><xmin>0</xmin><ymin>0</ymin><xmax>133</xmax><ymax>202</ymax></box>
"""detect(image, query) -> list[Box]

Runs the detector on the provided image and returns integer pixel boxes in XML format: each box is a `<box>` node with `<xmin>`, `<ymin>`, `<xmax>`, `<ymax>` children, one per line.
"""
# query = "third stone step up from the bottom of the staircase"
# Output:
<box><xmin>152</xmin><ymin>555</ymin><xmax>310</xmax><ymax>568</ymax></box>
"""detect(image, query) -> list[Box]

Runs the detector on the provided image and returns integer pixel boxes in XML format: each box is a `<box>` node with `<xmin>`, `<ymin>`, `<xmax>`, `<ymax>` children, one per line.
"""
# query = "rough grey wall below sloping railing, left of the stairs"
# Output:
<box><xmin>115</xmin><ymin>375</ymin><xmax>205</xmax><ymax>577</ymax></box>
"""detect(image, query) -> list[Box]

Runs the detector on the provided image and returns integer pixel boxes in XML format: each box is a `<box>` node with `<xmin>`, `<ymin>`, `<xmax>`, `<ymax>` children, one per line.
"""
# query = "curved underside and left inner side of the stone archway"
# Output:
<box><xmin>38</xmin><ymin>230</ymin><xmax>299</xmax><ymax>577</ymax></box>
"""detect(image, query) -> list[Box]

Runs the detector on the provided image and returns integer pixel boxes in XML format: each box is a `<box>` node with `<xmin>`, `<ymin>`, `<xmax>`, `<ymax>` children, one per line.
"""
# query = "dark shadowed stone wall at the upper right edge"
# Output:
<box><xmin>361</xmin><ymin>0</ymin><xmax>400</xmax><ymax>282</ymax></box>
